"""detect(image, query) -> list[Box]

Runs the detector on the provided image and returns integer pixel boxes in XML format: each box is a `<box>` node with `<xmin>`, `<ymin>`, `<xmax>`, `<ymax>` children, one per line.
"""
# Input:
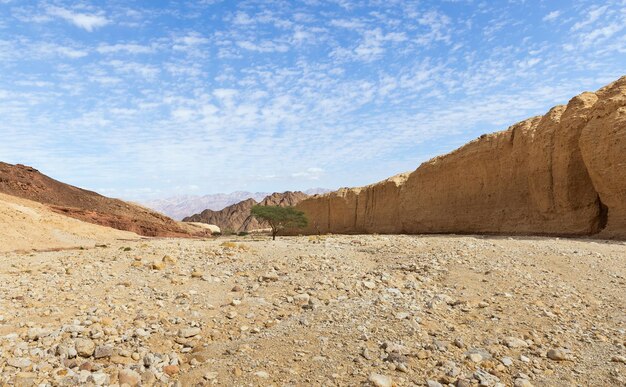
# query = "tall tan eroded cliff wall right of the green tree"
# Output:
<box><xmin>298</xmin><ymin>77</ymin><xmax>626</xmax><ymax>238</ymax></box>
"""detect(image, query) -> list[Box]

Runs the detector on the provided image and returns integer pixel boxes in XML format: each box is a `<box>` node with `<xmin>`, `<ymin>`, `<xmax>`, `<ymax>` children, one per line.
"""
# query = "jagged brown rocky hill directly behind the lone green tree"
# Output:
<box><xmin>183</xmin><ymin>191</ymin><xmax>308</xmax><ymax>232</ymax></box>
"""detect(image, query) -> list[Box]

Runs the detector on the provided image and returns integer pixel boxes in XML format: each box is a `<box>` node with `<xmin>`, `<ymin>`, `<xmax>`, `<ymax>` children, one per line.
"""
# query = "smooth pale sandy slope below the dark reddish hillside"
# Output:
<box><xmin>0</xmin><ymin>194</ymin><xmax>139</xmax><ymax>252</ymax></box>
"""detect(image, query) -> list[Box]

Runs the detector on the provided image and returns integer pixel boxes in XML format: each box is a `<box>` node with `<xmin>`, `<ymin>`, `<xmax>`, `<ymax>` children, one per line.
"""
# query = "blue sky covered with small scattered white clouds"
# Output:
<box><xmin>0</xmin><ymin>0</ymin><xmax>626</xmax><ymax>200</ymax></box>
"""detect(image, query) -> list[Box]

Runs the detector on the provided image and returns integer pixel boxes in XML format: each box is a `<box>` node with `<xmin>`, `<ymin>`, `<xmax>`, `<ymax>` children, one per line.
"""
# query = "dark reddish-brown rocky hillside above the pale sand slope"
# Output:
<box><xmin>0</xmin><ymin>162</ymin><xmax>196</xmax><ymax>236</ymax></box>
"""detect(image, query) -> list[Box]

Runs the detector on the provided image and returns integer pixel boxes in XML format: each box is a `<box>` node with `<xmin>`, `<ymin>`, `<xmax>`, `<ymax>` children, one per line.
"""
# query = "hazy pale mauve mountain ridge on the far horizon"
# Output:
<box><xmin>142</xmin><ymin>188</ymin><xmax>331</xmax><ymax>220</ymax></box>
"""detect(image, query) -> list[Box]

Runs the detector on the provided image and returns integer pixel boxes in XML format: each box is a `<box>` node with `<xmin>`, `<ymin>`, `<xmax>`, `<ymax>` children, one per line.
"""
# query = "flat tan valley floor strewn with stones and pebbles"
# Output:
<box><xmin>0</xmin><ymin>235</ymin><xmax>626</xmax><ymax>386</ymax></box>
